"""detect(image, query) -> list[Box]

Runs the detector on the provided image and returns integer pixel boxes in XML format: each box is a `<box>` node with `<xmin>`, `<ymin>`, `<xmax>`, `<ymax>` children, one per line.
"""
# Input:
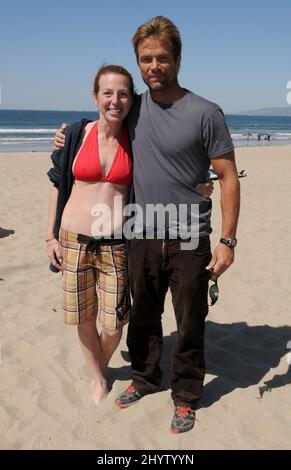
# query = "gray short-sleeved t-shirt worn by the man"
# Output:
<box><xmin>127</xmin><ymin>90</ymin><xmax>233</xmax><ymax>238</ymax></box>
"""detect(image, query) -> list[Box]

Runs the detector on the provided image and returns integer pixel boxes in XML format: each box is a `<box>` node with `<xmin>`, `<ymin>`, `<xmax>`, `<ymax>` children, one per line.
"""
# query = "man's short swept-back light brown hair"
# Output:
<box><xmin>131</xmin><ymin>16</ymin><xmax>182</xmax><ymax>61</ymax></box>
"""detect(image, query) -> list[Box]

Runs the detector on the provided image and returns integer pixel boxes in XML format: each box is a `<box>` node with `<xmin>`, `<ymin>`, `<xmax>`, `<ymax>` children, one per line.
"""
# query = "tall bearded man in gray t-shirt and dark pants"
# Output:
<box><xmin>53</xmin><ymin>16</ymin><xmax>239</xmax><ymax>433</ymax></box>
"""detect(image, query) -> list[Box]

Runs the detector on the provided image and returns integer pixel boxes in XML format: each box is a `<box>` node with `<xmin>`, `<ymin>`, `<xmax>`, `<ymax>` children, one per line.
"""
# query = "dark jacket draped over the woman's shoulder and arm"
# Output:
<box><xmin>47</xmin><ymin>119</ymin><xmax>91</xmax><ymax>238</ymax></box>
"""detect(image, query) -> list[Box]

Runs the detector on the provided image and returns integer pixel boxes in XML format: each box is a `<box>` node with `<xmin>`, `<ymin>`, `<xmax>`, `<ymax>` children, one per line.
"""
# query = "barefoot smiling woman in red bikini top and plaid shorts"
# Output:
<box><xmin>46</xmin><ymin>65</ymin><xmax>134</xmax><ymax>405</ymax></box>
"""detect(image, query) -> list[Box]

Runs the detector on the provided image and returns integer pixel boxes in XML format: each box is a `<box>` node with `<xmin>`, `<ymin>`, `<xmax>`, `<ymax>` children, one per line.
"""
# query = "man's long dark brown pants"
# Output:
<box><xmin>127</xmin><ymin>237</ymin><xmax>211</xmax><ymax>406</ymax></box>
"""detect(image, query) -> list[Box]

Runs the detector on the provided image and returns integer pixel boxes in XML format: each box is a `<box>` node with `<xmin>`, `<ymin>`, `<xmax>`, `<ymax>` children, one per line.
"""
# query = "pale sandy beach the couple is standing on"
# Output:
<box><xmin>0</xmin><ymin>145</ymin><xmax>291</xmax><ymax>450</ymax></box>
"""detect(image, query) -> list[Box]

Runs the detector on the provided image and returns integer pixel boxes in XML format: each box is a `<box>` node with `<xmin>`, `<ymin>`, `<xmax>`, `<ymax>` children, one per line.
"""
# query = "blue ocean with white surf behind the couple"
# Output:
<box><xmin>0</xmin><ymin>110</ymin><xmax>291</xmax><ymax>152</ymax></box>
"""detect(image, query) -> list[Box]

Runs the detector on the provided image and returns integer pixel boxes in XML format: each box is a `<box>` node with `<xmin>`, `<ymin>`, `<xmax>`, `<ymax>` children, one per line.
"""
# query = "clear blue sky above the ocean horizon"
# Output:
<box><xmin>0</xmin><ymin>0</ymin><xmax>291</xmax><ymax>113</ymax></box>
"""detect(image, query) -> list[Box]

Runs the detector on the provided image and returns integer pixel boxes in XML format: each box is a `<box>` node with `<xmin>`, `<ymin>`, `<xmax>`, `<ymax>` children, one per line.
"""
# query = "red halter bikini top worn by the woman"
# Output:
<box><xmin>73</xmin><ymin>121</ymin><xmax>132</xmax><ymax>186</ymax></box>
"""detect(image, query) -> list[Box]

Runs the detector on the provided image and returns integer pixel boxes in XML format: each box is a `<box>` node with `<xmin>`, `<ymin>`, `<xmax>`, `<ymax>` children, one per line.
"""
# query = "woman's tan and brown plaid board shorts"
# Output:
<box><xmin>59</xmin><ymin>228</ymin><xmax>130</xmax><ymax>330</ymax></box>
